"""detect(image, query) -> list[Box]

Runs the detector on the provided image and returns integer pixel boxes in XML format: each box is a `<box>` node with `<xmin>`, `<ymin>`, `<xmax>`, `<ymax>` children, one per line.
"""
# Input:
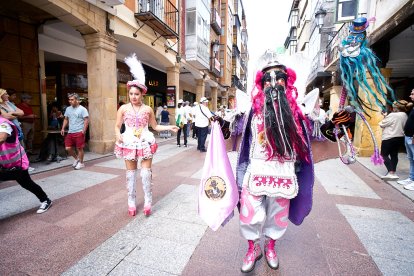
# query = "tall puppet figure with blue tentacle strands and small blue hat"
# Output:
<box><xmin>321</xmin><ymin>17</ymin><xmax>395</xmax><ymax>165</ymax></box>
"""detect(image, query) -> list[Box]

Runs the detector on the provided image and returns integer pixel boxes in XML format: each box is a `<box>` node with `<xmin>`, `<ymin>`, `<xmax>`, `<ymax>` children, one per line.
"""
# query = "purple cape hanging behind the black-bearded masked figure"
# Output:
<box><xmin>236</xmin><ymin>110</ymin><xmax>315</xmax><ymax>225</ymax></box>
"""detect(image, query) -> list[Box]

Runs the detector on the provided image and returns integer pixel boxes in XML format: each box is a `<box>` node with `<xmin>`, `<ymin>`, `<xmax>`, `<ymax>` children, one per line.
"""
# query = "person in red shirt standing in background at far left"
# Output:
<box><xmin>17</xmin><ymin>93</ymin><xmax>36</xmax><ymax>154</ymax></box>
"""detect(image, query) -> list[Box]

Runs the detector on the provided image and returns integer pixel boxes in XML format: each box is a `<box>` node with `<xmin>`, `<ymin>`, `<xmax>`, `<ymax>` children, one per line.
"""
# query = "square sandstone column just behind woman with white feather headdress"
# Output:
<box><xmin>83</xmin><ymin>33</ymin><xmax>118</xmax><ymax>154</ymax></box>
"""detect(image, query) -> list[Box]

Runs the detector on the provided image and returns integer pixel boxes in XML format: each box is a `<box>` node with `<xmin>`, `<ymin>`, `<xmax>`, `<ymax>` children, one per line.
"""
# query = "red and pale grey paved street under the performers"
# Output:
<box><xmin>0</xmin><ymin>139</ymin><xmax>414</xmax><ymax>275</ymax></box>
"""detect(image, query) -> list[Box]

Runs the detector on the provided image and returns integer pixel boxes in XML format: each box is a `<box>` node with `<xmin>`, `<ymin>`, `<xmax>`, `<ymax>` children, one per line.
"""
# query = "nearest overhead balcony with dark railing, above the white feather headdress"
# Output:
<box><xmin>135</xmin><ymin>0</ymin><xmax>178</xmax><ymax>39</ymax></box>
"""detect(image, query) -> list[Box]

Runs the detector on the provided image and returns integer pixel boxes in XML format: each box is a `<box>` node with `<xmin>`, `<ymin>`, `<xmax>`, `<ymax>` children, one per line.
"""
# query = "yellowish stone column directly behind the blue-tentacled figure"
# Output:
<box><xmin>354</xmin><ymin>68</ymin><xmax>392</xmax><ymax>157</ymax></box>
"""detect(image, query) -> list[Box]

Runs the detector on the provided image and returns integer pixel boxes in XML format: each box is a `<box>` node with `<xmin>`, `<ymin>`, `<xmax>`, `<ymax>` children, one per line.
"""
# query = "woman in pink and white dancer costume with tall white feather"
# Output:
<box><xmin>115</xmin><ymin>54</ymin><xmax>178</xmax><ymax>216</ymax></box>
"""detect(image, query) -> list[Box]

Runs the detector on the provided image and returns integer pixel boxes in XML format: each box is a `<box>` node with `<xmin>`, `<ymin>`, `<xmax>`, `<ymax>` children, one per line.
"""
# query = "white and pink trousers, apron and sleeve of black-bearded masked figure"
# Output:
<box><xmin>240</xmin><ymin>115</ymin><xmax>299</xmax><ymax>241</ymax></box>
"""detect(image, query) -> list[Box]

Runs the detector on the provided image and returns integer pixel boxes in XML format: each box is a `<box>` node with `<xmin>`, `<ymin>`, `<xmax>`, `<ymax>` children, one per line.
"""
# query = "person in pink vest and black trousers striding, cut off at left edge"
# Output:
<box><xmin>0</xmin><ymin>112</ymin><xmax>52</xmax><ymax>214</ymax></box>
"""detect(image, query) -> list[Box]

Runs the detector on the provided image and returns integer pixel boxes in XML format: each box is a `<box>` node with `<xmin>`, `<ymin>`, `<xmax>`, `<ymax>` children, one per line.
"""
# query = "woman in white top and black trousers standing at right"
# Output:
<box><xmin>379</xmin><ymin>100</ymin><xmax>413</xmax><ymax>179</ymax></box>
